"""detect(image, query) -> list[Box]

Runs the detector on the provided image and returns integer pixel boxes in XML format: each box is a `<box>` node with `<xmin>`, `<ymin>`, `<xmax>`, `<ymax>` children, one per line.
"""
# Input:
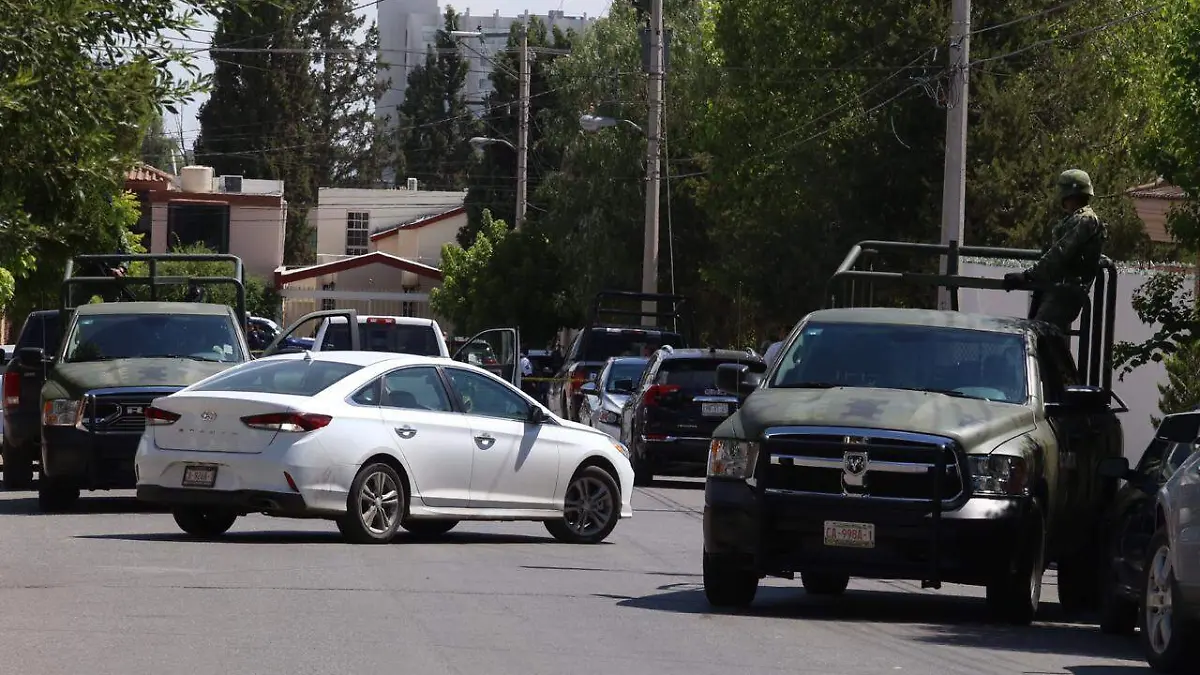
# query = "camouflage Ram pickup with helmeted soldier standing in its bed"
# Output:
<box><xmin>703</xmin><ymin>241</ymin><xmax>1128</xmax><ymax>623</ymax></box>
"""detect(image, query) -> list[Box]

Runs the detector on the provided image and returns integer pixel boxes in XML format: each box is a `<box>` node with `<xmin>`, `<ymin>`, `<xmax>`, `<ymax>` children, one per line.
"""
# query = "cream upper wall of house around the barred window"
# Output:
<box><xmin>317</xmin><ymin>187</ymin><xmax>467</xmax><ymax>256</ymax></box>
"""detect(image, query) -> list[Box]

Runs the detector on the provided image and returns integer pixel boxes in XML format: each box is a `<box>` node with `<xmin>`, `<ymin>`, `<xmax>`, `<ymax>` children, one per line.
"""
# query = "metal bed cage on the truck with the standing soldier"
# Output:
<box><xmin>826</xmin><ymin>240</ymin><xmax>1117</xmax><ymax>390</ymax></box>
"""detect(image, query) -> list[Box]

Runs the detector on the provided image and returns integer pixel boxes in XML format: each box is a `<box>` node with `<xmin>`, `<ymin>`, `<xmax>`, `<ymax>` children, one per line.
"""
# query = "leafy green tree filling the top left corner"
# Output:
<box><xmin>0</xmin><ymin>0</ymin><xmax>217</xmax><ymax>307</ymax></box>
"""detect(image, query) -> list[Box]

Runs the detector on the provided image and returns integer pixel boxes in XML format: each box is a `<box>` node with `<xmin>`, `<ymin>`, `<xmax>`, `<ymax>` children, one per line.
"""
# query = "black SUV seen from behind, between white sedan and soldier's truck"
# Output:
<box><xmin>614</xmin><ymin>347</ymin><xmax>767</xmax><ymax>485</ymax></box>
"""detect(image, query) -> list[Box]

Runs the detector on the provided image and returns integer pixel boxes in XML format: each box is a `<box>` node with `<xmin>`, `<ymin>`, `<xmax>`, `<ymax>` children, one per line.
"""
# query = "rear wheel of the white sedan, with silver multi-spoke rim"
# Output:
<box><xmin>337</xmin><ymin>464</ymin><xmax>407</xmax><ymax>544</ymax></box>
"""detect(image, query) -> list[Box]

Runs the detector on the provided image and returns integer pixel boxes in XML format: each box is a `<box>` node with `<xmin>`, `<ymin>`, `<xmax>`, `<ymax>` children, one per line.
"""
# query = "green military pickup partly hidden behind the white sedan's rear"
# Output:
<box><xmin>17</xmin><ymin>253</ymin><xmax>250</xmax><ymax>512</ymax></box>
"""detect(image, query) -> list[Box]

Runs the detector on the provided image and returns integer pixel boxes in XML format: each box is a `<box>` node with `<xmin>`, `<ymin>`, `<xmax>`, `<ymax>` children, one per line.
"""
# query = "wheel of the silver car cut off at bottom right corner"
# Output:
<box><xmin>1138</xmin><ymin>530</ymin><xmax>1200</xmax><ymax>673</ymax></box>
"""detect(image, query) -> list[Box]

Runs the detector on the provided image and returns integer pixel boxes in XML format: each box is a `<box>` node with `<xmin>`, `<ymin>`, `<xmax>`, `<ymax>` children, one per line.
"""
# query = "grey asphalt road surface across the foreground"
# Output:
<box><xmin>0</xmin><ymin>483</ymin><xmax>1148</xmax><ymax>675</ymax></box>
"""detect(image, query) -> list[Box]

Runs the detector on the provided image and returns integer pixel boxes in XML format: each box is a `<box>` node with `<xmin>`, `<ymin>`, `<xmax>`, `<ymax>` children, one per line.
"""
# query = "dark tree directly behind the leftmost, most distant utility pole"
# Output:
<box><xmin>458</xmin><ymin>16</ymin><xmax>578</xmax><ymax>246</ymax></box>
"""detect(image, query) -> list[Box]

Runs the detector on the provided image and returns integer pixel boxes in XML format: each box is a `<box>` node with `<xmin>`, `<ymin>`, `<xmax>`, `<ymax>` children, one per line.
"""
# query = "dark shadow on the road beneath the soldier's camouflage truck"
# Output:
<box><xmin>617</xmin><ymin>584</ymin><xmax>1144</xmax><ymax>658</ymax></box>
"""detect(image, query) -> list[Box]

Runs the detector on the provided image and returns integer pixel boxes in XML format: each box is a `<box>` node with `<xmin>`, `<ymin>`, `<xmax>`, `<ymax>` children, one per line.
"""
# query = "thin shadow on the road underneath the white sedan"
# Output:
<box><xmin>74</xmin><ymin>528</ymin><xmax>556</xmax><ymax>545</ymax></box>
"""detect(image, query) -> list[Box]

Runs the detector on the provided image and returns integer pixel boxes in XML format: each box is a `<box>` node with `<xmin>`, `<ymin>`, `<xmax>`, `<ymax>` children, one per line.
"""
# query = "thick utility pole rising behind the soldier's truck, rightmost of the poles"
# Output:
<box><xmin>937</xmin><ymin>0</ymin><xmax>971</xmax><ymax>310</ymax></box>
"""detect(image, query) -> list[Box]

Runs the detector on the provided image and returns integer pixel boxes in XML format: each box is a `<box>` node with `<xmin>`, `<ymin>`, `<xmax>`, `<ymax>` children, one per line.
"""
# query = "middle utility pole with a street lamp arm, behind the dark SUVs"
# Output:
<box><xmin>642</xmin><ymin>0</ymin><xmax>664</xmax><ymax>325</ymax></box>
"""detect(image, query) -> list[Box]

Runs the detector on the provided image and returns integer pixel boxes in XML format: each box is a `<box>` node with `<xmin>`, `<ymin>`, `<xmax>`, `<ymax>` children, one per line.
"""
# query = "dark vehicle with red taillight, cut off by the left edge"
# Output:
<box><xmin>0</xmin><ymin>310</ymin><xmax>60</xmax><ymax>490</ymax></box>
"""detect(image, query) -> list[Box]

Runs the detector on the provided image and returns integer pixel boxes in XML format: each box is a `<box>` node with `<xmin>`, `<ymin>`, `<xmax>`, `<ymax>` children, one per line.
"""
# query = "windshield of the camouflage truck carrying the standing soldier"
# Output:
<box><xmin>769</xmin><ymin>323</ymin><xmax>1027</xmax><ymax>402</ymax></box>
